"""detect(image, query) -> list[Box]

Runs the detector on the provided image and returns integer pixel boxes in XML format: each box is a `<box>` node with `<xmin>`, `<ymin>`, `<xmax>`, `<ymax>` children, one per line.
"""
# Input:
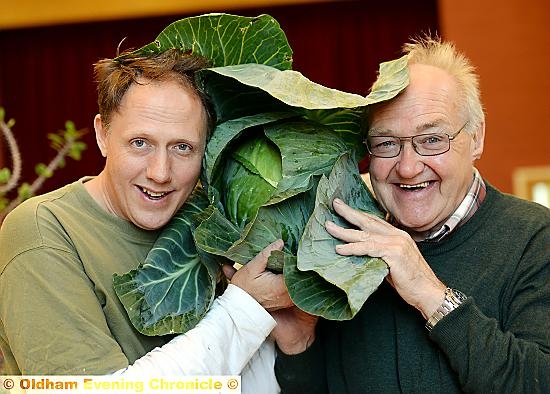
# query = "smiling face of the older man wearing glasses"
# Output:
<box><xmin>369</xmin><ymin>64</ymin><xmax>484</xmax><ymax>237</ymax></box>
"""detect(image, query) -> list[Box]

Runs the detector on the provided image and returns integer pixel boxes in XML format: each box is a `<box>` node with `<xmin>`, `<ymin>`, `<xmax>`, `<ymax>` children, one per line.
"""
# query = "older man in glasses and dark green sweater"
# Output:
<box><xmin>276</xmin><ymin>37</ymin><xmax>550</xmax><ymax>393</ymax></box>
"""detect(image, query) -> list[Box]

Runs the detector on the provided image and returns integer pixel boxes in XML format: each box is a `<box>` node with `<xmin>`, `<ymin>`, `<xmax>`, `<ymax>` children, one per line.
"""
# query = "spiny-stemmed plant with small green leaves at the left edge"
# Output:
<box><xmin>0</xmin><ymin>107</ymin><xmax>86</xmax><ymax>224</ymax></box>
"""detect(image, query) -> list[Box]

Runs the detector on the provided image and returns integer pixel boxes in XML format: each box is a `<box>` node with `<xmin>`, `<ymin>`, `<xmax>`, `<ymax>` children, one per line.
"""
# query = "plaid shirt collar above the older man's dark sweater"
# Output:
<box><xmin>424</xmin><ymin>168</ymin><xmax>487</xmax><ymax>242</ymax></box>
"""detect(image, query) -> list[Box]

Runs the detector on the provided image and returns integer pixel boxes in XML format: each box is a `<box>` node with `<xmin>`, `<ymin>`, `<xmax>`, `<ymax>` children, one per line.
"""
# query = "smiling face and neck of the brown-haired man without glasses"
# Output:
<box><xmin>85</xmin><ymin>81</ymin><xmax>207</xmax><ymax>230</ymax></box>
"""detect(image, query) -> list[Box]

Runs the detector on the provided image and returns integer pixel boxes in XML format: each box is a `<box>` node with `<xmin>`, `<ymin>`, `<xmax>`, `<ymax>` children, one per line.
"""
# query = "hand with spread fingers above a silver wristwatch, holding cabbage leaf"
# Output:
<box><xmin>326</xmin><ymin>199</ymin><xmax>446</xmax><ymax>319</ymax></box>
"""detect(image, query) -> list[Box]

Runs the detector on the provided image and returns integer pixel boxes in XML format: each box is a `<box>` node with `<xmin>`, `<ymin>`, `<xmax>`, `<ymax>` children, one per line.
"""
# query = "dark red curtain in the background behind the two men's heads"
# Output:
<box><xmin>0</xmin><ymin>0</ymin><xmax>438</xmax><ymax>196</ymax></box>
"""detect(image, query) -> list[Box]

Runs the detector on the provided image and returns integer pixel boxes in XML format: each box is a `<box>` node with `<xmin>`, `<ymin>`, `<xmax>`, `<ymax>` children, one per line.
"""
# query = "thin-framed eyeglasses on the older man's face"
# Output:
<box><xmin>365</xmin><ymin>122</ymin><xmax>468</xmax><ymax>158</ymax></box>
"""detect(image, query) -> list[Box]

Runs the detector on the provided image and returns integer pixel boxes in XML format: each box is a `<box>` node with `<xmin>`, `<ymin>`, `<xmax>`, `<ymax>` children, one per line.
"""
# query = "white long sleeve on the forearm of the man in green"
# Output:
<box><xmin>113</xmin><ymin>284</ymin><xmax>276</xmax><ymax>379</ymax></box>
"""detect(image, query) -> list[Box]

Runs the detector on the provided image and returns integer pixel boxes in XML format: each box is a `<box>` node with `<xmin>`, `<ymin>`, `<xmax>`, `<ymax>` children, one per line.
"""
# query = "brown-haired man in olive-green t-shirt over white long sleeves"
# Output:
<box><xmin>0</xmin><ymin>50</ymin><xmax>291</xmax><ymax>389</ymax></box>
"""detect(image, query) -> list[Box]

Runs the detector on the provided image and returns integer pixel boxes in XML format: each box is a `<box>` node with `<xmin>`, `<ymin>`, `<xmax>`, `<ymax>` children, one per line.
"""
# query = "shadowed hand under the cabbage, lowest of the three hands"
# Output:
<box><xmin>270</xmin><ymin>306</ymin><xmax>319</xmax><ymax>355</ymax></box>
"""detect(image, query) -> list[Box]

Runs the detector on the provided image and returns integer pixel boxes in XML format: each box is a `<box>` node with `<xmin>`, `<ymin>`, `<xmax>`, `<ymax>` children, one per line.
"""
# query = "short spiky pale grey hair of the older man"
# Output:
<box><xmin>403</xmin><ymin>35</ymin><xmax>485</xmax><ymax>133</ymax></box>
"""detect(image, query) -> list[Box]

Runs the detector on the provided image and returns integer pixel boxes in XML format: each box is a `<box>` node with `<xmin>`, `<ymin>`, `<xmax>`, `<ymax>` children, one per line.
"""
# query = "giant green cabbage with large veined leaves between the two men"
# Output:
<box><xmin>114</xmin><ymin>14</ymin><xmax>408</xmax><ymax>335</ymax></box>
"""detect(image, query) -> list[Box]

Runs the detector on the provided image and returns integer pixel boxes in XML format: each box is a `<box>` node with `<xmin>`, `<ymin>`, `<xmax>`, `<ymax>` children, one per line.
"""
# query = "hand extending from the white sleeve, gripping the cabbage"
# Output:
<box><xmin>223</xmin><ymin>240</ymin><xmax>294</xmax><ymax>311</ymax></box>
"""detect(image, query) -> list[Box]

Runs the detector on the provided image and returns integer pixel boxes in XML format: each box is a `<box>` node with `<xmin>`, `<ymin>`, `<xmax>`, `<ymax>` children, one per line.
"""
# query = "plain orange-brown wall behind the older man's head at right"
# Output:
<box><xmin>439</xmin><ymin>0</ymin><xmax>550</xmax><ymax>192</ymax></box>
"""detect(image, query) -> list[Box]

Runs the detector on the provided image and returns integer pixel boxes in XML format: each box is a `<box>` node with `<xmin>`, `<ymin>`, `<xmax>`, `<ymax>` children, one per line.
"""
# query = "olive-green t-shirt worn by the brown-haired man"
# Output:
<box><xmin>0</xmin><ymin>178</ymin><xmax>169</xmax><ymax>375</ymax></box>
